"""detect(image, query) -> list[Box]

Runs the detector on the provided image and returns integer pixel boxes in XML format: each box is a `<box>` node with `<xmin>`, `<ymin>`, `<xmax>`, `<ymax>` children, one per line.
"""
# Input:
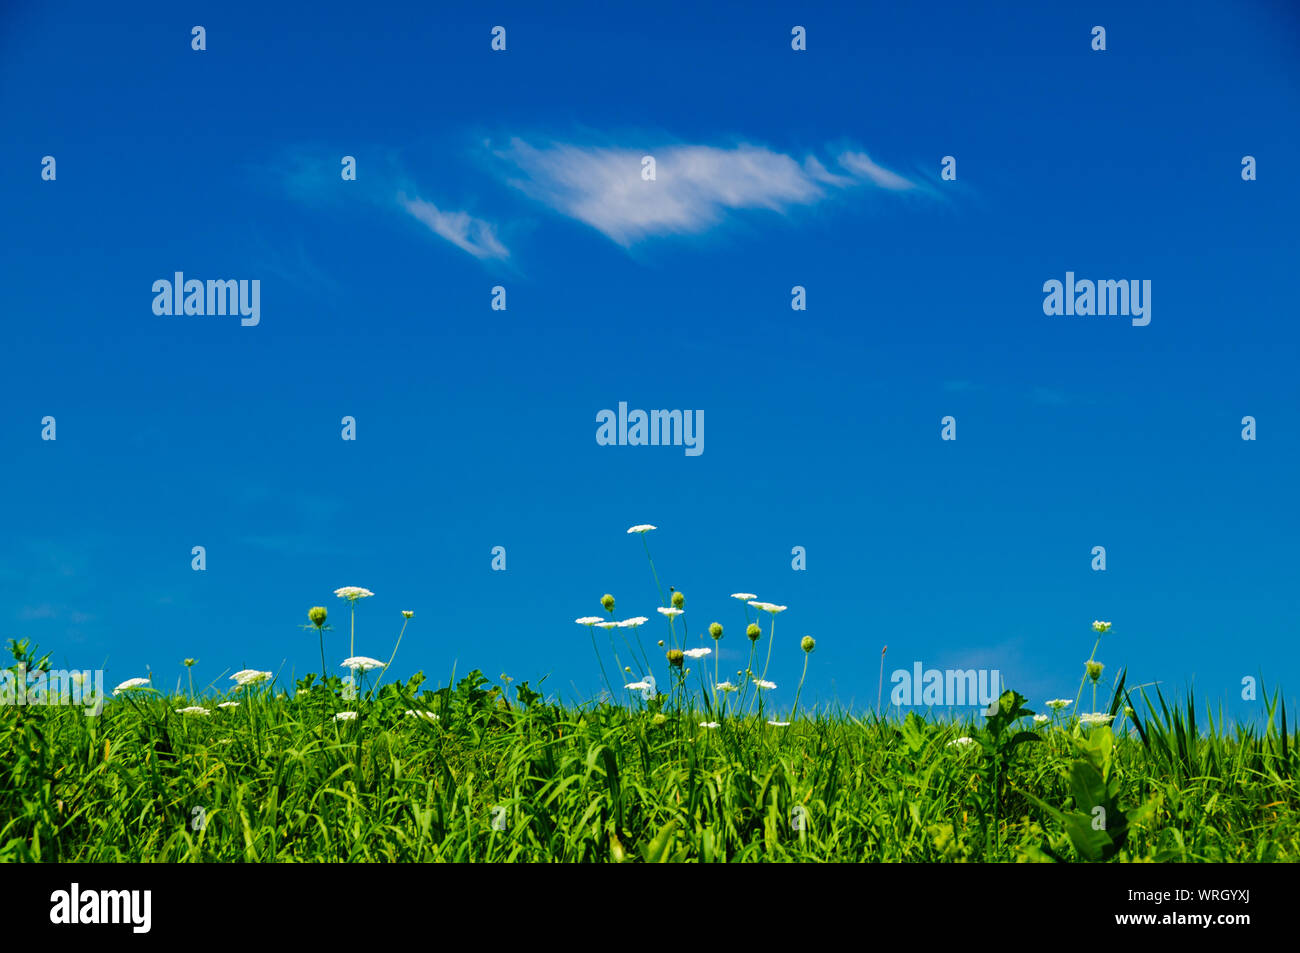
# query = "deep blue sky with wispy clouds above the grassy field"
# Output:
<box><xmin>0</xmin><ymin>1</ymin><xmax>1300</xmax><ymax>718</ymax></box>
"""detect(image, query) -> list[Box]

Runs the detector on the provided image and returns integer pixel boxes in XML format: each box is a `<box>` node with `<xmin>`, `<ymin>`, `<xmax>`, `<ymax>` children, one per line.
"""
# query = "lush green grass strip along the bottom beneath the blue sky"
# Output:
<box><xmin>0</xmin><ymin>659</ymin><xmax>1300</xmax><ymax>862</ymax></box>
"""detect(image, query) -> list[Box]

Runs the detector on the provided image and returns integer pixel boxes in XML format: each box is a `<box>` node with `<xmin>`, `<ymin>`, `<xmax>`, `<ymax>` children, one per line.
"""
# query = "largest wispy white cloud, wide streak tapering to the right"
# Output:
<box><xmin>497</xmin><ymin>139</ymin><xmax>915</xmax><ymax>246</ymax></box>
